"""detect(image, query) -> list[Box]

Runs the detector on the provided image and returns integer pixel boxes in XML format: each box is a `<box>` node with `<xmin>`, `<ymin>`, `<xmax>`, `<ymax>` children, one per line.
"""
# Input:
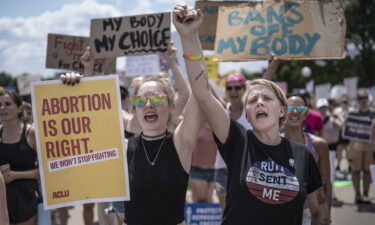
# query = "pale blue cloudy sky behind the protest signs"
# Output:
<box><xmin>0</xmin><ymin>0</ymin><xmax>267</xmax><ymax>77</ymax></box>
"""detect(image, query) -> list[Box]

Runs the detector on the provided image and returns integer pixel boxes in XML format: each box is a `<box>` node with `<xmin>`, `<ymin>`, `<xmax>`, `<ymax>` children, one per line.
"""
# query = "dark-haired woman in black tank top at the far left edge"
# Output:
<box><xmin>0</xmin><ymin>90</ymin><xmax>39</xmax><ymax>225</ymax></box>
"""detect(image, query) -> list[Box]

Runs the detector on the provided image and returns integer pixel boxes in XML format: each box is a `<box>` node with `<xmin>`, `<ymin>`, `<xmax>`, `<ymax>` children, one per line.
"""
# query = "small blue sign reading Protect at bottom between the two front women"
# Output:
<box><xmin>185</xmin><ymin>203</ymin><xmax>223</xmax><ymax>225</ymax></box>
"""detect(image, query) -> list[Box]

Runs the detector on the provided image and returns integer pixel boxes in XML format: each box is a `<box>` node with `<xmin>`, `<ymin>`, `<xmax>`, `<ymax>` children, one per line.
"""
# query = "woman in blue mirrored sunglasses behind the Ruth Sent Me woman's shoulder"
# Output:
<box><xmin>284</xmin><ymin>95</ymin><xmax>332</xmax><ymax>225</ymax></box>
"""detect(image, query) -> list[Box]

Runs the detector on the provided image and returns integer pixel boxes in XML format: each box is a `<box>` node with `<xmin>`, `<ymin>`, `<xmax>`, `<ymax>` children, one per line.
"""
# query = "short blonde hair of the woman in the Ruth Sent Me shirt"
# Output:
<box><xmin>244</xmin><ymin>79</ymin><xmax>288</xmax><ymax>127</ymax></box>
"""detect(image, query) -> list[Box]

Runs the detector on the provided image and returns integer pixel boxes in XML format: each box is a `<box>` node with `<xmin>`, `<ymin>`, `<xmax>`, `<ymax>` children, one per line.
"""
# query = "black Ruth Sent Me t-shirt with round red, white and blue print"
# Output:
<box><xmin>215</xmin><ymin>120</ymin><xmax>322</xmax><ymax>225</ymax></box>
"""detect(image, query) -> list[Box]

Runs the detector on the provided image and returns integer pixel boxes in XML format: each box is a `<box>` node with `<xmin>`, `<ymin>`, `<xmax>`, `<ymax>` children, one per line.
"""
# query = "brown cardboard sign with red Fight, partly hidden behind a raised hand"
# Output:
<box><xmin>46</xmin><ymin>34</ymin><xmax>116</xmax><ymax>75</ymax></box>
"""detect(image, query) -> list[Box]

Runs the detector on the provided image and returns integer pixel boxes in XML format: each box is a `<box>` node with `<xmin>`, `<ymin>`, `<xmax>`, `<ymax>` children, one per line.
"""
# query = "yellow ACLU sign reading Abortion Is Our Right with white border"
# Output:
<box><xmin>31</xmin><ymin>75</ymin><xmax>130</xmax><ymax>209</ymax></box>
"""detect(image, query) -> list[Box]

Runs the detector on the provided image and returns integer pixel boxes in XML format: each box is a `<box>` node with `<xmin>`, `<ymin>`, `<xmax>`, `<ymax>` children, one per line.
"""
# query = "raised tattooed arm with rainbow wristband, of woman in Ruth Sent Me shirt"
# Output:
<box><xmin>173</xmin><ymin>4</ymin><xmax>230</xmax><ymax>143</ymax></box>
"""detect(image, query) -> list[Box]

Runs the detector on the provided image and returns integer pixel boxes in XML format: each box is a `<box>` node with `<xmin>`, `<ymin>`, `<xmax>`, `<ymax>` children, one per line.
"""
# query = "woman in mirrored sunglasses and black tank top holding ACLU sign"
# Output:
<box><xmin>62</xmin><ymin>69</ymin><xmax>202</xmax><ymax>225</ymax></box>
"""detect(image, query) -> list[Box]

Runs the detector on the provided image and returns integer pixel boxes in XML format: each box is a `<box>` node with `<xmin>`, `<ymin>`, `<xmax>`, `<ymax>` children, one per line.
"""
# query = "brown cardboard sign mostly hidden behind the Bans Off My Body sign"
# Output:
<box><xmin>195</xmin><ymin>1</ymin><xmax>246</xmax><ymax>50</ymax></box>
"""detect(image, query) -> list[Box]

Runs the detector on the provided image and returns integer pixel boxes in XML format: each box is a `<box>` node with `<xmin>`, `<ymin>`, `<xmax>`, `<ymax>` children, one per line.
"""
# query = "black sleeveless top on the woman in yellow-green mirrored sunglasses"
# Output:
<box><xmin>125</xmin><ymin>133</ymin><xmax>189</xmax><ymax>225</ymax></box>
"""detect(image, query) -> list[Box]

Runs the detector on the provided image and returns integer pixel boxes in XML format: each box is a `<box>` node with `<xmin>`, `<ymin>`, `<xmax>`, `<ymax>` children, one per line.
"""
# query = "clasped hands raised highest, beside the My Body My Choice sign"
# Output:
<box><xmin>173</xmin><ymin>4</ymin><xmax>203</xmax><ymax>36</ymax></box>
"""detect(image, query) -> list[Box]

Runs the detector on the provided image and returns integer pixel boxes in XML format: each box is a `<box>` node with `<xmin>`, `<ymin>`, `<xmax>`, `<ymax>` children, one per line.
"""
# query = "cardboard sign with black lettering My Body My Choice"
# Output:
<box><xmin>90</xmin><ymin>13</ymin><xmax>171</xmax><ymax>58</ymax></box>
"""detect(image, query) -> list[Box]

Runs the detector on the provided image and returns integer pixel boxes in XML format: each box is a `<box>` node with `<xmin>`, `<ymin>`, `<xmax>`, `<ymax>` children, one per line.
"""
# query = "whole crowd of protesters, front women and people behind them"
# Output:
<box><xmin>0</xmin><ymin>4</ymin><xmax>375</xmax><ymax>225</ymax></box>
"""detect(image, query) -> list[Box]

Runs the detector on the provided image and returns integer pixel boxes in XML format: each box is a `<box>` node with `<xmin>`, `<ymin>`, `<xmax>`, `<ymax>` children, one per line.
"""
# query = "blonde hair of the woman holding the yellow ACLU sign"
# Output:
<box><xmin>130</xmin><ymin>73</ymin><xmax>175</xmax><ymax>105</ymax></box>
